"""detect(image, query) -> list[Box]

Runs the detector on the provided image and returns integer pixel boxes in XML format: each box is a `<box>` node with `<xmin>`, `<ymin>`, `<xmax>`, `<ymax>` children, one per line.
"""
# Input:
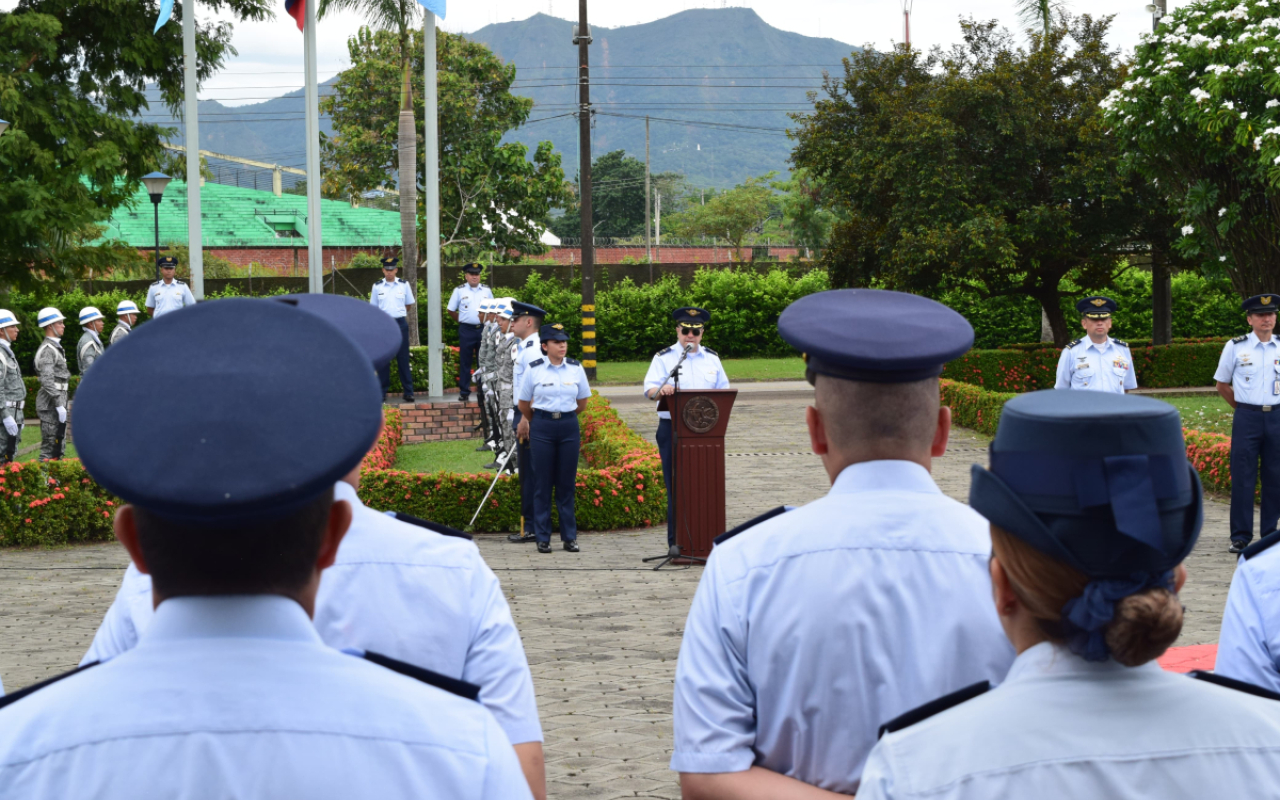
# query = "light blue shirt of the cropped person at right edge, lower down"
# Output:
<box><xmin>1213</xmin><ymin>545</ymin><xmax>1280</xmax><ymax>691</ymax></box>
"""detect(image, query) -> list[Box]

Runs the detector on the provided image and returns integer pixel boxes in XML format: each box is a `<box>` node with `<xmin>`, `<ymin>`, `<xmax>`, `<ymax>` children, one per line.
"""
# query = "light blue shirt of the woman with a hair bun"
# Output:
<box><xmin>858</xmin><ymin>643</ymin><xmax>1280</xmax><ymax>800</ymax></box>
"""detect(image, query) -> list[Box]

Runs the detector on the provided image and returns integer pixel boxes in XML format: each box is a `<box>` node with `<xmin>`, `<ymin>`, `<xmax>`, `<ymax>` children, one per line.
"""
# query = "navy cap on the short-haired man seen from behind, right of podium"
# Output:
<box><xmin>778</xmin><ymin>289</ymin><xmax>973</xmax><ymax>383</ymax></box>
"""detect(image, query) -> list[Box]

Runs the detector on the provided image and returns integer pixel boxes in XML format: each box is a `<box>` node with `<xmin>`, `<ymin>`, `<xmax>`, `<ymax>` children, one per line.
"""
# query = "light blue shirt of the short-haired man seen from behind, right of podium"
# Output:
<box><xmin>671</xmin><ymin>461</ymin><xmax>1014</xmax><ymax>794</ymax></box>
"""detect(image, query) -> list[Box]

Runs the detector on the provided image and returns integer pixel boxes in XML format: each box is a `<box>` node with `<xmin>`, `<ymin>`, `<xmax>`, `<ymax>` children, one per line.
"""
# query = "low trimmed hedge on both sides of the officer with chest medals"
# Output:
<box><xmin>942</xmin><ymin>339</ymin><xmax>1225</xmax><ymax>393</ymax></box>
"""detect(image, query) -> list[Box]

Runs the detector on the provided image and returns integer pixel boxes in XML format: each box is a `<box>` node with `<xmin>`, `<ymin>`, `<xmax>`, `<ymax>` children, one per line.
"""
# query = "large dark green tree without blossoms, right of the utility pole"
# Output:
<box><xmin>792</xmin><ymin>15</ymin><xmax>1144</xmax><ymax>343</ymax></box>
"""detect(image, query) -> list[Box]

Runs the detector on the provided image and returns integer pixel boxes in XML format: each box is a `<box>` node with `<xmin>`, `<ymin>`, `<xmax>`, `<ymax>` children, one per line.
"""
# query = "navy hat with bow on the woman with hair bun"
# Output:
<box><xmin>969</xmin><ymin>389</ymin><xmax>1203</xmax><ymax>579</ymax></box>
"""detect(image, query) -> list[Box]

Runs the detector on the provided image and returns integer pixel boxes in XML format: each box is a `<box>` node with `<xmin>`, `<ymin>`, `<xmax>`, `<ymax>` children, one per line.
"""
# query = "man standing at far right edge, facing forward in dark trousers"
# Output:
<box><xmin>1213</xmin><ymin>294</ymin><xmax>1280</xmax><ymax>553</ymax></box>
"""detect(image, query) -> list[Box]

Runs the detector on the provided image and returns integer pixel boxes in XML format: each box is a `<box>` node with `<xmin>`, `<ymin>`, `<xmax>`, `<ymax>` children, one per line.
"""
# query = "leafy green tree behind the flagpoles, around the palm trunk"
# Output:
<box><xmin>321</xmin><ymin>28</ymin><xmax>570</xmax><ymax>266</ymax></box>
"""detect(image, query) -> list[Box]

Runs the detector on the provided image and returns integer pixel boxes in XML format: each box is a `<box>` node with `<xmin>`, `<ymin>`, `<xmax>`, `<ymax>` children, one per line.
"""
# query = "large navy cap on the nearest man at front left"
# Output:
<box><xmin>76</xmin><ymin>298</ymin><xmax>383</xmax><ymax>525</ymax></box>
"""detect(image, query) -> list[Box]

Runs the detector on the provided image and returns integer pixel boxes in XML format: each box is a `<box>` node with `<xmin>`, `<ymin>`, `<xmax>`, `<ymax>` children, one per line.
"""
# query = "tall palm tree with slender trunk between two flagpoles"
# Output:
<box><xmin>316</xmin><ymin>0</ymin><xmax>419</xmax><ymax>344</ymax></box>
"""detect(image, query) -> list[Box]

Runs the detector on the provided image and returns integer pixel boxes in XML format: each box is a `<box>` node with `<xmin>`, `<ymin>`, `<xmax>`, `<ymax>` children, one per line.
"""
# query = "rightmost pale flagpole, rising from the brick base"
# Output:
<box><xmin>422</xmin><ymin>9</ymin><xmax>444</xmax><ymax>398</ymax></box>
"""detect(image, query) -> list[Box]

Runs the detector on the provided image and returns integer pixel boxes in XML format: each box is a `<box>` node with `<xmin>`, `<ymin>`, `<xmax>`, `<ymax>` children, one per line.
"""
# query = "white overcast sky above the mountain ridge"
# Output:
<box><xmin>0</xmin><ymin>0</ymin><xmax>1187</xmax><ymax>105</ymax></box>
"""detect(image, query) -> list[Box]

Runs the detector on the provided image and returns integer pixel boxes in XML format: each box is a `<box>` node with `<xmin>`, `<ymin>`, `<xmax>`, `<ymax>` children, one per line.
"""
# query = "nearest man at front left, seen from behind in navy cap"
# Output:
<box><xmin>0</xmin><ymin>298</ymin><xmax>530</xmax><ymax>800</ymax></box>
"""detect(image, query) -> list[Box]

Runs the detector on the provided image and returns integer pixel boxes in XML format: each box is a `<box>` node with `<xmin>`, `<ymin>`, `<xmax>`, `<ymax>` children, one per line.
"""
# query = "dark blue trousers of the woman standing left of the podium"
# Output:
<box><xmin>529</xmin><ymin>408</ymin><xmax>581</xmax><ymax>541</ymax></box>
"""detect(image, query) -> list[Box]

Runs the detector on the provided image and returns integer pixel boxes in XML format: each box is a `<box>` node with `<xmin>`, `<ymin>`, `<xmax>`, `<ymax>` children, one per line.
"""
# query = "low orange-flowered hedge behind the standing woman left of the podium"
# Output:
<box><xmin>360</xmin><ymin>392</ymin><xmax>667</xmax><ymax>531</ymax></box>
